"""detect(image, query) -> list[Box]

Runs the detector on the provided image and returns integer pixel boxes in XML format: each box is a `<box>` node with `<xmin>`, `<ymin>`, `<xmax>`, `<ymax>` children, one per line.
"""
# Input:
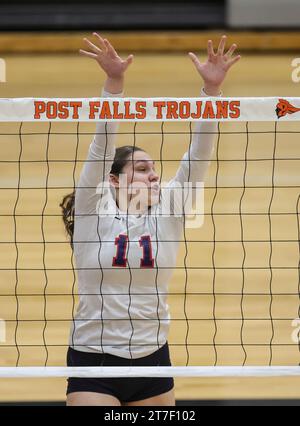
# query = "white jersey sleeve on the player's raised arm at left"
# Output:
<box><xmin>75</xmin><ymin>90</ymin><xmax>123</xmax><ymax>215</ymax></box>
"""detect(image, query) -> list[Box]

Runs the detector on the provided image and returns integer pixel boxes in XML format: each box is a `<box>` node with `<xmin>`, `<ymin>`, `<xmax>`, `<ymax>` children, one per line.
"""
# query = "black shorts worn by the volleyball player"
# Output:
<box><xmin>67</xmin><ymin>343</ymin><xmax>174</xmax><ymax>403</ymax></box>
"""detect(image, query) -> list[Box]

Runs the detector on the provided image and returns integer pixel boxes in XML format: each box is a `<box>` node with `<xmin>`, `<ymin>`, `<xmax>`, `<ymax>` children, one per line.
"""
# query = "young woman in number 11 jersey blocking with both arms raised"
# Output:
<box><xmin>61</xmin><ymin>33</ymin><xmax>240</xmax><ymax>406</ymax></box>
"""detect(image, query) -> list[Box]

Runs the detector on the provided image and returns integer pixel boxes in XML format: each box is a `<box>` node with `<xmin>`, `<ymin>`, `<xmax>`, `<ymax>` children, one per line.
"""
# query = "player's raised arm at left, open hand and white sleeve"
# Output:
<box><xmin>75</xmin><ymin>33</ymin><xmax>133</xmax><ymax>215</ymax></box>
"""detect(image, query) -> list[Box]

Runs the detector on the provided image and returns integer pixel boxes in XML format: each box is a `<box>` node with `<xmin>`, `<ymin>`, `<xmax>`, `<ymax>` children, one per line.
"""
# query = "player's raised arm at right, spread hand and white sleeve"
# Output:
<box><xmin>170</xmin><ymin>36</ymin><xmax>241</xmax><ymax>215</ymax></box>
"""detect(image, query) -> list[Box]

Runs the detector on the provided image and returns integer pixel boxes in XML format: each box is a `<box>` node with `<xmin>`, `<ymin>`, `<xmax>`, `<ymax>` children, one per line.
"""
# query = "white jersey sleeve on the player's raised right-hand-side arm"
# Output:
<box><xmin>164</xmin><ymin>90</ymin><xmax>217</xmax><ymax>216</ymax></box>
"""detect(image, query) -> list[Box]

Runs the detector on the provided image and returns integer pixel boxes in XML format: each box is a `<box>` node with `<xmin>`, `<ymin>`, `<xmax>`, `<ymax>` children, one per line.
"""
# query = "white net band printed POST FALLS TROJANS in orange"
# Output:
<box><xmin>0</xmin><ymin>97</ymin><xmax>300</xmax><ymax>122</ymax></box>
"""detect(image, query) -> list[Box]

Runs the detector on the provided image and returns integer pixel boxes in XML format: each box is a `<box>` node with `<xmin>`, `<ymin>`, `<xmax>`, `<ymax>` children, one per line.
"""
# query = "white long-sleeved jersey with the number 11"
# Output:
<box><xmin>69</xmin><ymin>88</ymin><xmax>216</xmax><ymax>359</ymax></box>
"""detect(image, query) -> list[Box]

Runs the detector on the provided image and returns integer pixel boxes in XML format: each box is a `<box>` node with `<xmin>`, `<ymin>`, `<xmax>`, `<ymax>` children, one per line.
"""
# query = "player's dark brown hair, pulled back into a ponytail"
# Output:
<box><xmin>59</xmin><ymin>145</ymin><xmax>145</xmax><ymax>248</ymax></box>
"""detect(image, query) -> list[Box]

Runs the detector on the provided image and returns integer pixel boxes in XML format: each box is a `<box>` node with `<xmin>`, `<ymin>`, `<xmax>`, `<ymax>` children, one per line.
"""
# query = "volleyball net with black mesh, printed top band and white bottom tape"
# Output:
<box><xmin>0</xmin><ymin>98</ymin><xmax>300</xmax><ymax>377</ymax></box>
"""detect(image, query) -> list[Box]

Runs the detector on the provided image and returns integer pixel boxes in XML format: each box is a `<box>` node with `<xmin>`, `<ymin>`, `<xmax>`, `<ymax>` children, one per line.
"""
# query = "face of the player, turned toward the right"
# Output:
<box><xmin>122</xmin><ymin>151</ymin><xmax>160</xmax><ymax>206</ymax></box>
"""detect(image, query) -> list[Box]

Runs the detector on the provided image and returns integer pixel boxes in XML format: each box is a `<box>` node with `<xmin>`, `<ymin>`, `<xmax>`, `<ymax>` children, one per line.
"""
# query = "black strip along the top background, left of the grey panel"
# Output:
<box><xmin>0</xmin><ymin>0</ymin><xmax>226</xmax><ymax>31</ymax></box>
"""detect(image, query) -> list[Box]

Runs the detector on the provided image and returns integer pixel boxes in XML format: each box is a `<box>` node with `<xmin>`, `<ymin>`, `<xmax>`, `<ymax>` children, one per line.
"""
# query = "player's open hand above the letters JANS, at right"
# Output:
<box><xmin>189</xmin><ymin>36</ymin><xmax>241</xmax><ymax>96</ymax></box>
